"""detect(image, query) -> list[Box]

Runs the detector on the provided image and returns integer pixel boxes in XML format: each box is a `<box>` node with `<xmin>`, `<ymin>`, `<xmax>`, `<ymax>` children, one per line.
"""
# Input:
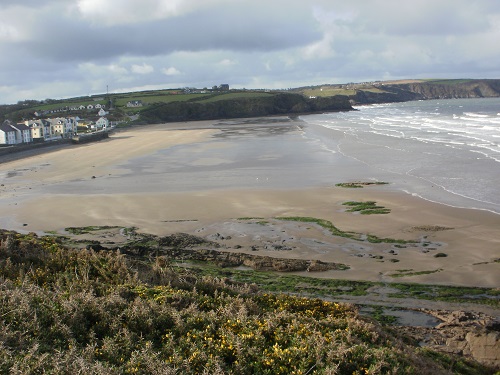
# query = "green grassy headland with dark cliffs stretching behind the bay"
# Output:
<box><xmin>0</xmin><ymin>79</ymin><xmax>500</xmax><ymax>124</ymax></box>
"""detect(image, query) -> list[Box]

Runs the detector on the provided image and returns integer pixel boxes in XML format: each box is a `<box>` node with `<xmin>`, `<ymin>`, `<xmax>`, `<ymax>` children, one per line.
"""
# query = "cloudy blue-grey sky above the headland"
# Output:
<box><xmin>0</xmin><ymin>0</ymin><xmax>500</xmax><ymax>104</ymax></box>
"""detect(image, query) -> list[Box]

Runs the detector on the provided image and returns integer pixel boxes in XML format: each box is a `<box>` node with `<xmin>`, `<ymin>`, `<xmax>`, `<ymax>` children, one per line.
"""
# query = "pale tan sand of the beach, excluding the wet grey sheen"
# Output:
<box><xmin>0</xmin><ymin>122</ymin><xmax>500</xmax><ymax>287</ymax></box>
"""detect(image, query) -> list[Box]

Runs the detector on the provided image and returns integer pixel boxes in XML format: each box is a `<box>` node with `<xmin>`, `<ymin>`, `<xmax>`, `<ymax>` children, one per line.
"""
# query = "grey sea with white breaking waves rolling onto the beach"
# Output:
<box><xmin>301</xmin><ymin>98</ymin><xmax>500</xmax><ymax>214</ymax></box>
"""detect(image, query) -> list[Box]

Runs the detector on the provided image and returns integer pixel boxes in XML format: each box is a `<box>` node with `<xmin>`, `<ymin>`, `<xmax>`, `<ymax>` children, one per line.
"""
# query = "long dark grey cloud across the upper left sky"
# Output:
<box><xmin>19</xmin><ymin>3</ymin><xmax>321</xmax><ymax>61</ymax></box>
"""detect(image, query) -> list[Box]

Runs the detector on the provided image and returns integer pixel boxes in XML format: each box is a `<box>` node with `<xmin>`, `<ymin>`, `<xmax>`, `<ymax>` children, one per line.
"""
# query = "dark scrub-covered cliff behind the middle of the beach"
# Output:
<box><xmin>141</xmin><ymin>93</ymin><xmax>353</xmax><ymax>123</ymax></box>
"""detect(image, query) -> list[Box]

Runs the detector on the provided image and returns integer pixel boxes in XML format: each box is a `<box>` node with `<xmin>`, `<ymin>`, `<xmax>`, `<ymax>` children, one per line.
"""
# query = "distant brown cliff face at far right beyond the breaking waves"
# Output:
<box><xmin>350</xmin><ymin>79</ymin><xmax>500</xmax><ymax>104</ymax></box>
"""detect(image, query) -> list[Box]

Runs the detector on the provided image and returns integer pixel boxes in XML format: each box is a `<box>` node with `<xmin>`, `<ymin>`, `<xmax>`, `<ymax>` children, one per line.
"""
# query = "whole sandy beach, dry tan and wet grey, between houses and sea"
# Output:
<box><xmin>0</xmin><ymin>121</ymin><xmax>500</xmax><ymax>287</ymax></box>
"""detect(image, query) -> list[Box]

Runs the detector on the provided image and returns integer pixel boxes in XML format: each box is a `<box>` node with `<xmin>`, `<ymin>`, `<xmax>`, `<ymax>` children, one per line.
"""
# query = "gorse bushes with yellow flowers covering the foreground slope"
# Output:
<box><xmin>0</xmin><ymin>231</ymin><xmax>490</xmax><ymax>374</ymax></box>
